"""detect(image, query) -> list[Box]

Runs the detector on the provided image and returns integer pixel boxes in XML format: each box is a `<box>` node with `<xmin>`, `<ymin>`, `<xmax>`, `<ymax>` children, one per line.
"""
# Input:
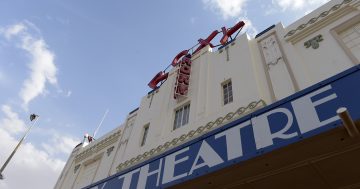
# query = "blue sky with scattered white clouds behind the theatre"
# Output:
<box><xmin>0</xmin><ymin>0</ymin><xmax>327</xmax><ymax>189</ymax></box>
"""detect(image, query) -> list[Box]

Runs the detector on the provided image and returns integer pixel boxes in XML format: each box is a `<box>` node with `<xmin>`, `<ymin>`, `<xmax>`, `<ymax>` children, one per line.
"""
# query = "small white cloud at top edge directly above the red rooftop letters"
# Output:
<box><xmin>202</xmin><ymin>0</ymin><xmax>247</xmax><ymax>20</ymax></box>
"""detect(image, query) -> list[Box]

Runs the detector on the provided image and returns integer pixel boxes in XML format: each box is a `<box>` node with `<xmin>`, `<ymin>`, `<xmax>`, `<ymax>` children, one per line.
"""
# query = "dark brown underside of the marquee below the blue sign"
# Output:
<box><xmin>171</xmin><ymin>120</ymin><xmax>360</xmax><ymax>189</ymax></box>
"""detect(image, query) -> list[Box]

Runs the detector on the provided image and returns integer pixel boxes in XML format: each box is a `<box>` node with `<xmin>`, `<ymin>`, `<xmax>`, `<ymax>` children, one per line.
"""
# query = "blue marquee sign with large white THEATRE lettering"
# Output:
<box><xmin>86</xmin><ymin>66</ymin><xmax>360</xmax><ymax>189</ymax></box>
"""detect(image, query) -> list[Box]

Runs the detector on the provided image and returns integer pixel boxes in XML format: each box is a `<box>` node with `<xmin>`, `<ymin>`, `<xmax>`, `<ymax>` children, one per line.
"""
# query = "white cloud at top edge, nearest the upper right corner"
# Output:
<box><xmin>272</xmin><ymin>0</ymin><xmax>329</xmax><ymax>11</ymax></box>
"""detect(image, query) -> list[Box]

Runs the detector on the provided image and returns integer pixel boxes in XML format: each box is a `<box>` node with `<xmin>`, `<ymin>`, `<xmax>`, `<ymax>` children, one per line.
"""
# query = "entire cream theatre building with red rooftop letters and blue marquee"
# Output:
<box><xmin>55</xmin><ymin>0</ymin><xmax>360</xmax><ymax>189</ymax></box>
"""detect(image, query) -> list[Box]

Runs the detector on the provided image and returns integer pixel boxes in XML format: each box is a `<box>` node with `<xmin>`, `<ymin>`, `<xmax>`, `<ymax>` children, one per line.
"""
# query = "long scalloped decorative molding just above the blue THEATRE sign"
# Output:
<box><xmin>116</xmin><ymin>100</ymin><xmax>266</xmax><ymax>172</ymax></box>
